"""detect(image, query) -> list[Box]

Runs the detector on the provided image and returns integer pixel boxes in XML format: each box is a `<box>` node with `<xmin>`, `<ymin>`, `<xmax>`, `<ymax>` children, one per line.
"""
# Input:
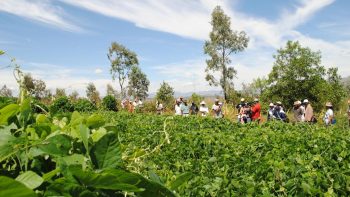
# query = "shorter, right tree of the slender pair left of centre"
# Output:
<box><xmin>128</xmin><ymin>66</ymin><xmax>150</xmax><ymax>99</ymax></box>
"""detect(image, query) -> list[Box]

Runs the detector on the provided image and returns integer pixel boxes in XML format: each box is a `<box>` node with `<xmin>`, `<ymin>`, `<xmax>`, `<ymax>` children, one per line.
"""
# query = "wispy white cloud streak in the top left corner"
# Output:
<box><xmin>0</xmin><ymin>0</ymin><xmax>82</xmax><ymax>32</ymax></box>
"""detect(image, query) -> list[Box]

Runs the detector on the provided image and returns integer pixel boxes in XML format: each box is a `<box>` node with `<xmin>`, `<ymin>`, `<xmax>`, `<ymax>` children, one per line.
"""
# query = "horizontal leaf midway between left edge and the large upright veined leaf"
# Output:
<box><xmin>38</xmin><ymin>134</ymin><xmax>73</xmax><ymax>156</ymax></box>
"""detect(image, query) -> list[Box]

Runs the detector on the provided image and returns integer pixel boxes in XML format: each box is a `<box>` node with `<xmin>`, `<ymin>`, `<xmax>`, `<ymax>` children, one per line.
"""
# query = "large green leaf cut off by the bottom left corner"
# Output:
<box><xmin>0</xmin><ymin>176</ymin><xmax>36</xmax><ymax>197</ymax></box>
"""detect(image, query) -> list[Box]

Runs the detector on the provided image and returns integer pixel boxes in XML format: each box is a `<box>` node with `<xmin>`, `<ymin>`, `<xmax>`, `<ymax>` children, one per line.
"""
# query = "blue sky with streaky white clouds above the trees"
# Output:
<box><xmin>0</xmin><ymin>0</ymin><xmax>350</xmax><ymax>96</ymax></box>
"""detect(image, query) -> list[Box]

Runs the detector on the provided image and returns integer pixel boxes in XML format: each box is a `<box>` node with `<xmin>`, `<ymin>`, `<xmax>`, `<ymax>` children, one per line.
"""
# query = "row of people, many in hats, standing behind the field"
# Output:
<box><xmin>157</xmin><ymin>97</ymin><xmax>350</xmax><ymax>126</ymax></box>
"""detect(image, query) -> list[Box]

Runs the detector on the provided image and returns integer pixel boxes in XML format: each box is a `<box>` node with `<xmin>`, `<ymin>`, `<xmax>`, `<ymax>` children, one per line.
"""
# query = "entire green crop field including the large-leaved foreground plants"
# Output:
<box><xmin>0</xmin><ymin>102</ymin><xmax>350</xmax><ymax>196</ymax></box>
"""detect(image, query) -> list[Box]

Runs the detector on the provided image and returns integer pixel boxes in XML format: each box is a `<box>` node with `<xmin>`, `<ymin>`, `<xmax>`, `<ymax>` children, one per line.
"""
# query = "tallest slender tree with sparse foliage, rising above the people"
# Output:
<box><xmin>204</xmin><ymin>6</ymin><xmax>249</xmax><ymax>100</ymax></box>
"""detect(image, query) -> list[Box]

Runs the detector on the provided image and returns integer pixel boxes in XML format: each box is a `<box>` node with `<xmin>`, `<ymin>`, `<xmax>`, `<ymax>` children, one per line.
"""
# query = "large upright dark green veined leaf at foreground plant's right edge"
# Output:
<box><xmin>91</xmin><ymin>133</ymin><xmax>122</xmax><ymax>169</ymax></box>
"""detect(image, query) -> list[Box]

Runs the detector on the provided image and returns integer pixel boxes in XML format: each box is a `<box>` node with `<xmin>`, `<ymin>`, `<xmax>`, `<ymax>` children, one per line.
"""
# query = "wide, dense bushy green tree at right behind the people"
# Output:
<box><xmin>262</xmin><ymin>41</ymin><xmax>344</xmax><ymax>111</ymax></box>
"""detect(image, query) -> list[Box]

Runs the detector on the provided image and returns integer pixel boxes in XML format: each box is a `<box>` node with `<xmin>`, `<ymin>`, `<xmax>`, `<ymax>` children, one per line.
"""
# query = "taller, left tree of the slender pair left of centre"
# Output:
<box><xmin>107</xmin><ymin>42</ymin><xmax>139</xmax><ymax>97</ymax></box>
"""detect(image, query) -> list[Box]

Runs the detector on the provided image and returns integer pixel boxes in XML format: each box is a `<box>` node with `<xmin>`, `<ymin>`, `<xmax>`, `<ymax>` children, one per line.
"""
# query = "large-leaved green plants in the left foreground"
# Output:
<box><xmin>0</xmin><ymin>100</ymin><xmax>175</xmax><ymax>196</ymax></box>
